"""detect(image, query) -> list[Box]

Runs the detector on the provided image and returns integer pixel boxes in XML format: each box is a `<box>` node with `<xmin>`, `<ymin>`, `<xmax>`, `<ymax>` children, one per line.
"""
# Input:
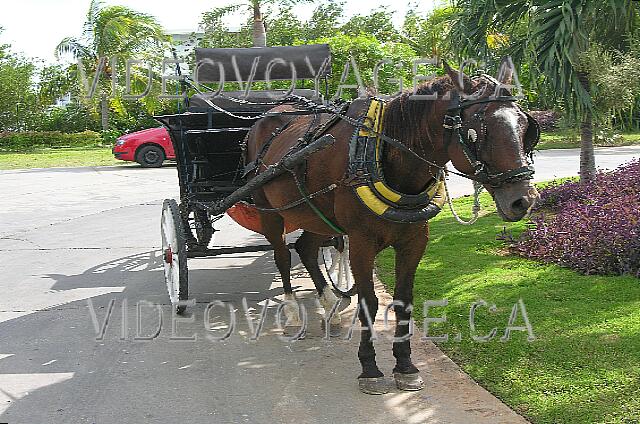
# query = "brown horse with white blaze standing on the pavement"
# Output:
<box><xmin>247</xmin><ymin>64</ymin><xmax>538</xmax><ymax>394</ymax></box>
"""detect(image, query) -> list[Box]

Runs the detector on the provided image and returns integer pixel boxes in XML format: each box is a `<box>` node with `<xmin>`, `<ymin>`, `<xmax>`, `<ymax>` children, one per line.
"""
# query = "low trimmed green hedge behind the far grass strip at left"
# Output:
<box><xmin>0</xmin><ymin>131</ymin><xmax>105</xmax><ymax>152</ymax></box>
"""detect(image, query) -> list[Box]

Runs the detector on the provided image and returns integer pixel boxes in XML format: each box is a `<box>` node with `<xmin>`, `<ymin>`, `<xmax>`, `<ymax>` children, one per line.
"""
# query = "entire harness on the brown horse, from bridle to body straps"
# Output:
<box><xmin>190</xmin><ymin>74</ymin><xmax>540</xmax><ymax>229</ymax></box>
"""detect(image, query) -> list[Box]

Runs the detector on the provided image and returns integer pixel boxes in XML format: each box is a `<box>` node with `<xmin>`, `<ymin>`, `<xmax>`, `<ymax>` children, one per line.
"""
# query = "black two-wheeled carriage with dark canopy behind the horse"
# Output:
<box><xmin>156</xmin><ymin>45</ymin><xmax>353</xmax><ymax>313</ymax></box>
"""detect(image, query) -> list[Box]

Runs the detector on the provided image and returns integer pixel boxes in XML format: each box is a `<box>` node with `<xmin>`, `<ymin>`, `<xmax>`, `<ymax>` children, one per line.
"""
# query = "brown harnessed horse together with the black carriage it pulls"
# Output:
<box><xmin>157</xmin><ymin>45</ymin><xmax>539</xmax><ymax>394</ymax></box>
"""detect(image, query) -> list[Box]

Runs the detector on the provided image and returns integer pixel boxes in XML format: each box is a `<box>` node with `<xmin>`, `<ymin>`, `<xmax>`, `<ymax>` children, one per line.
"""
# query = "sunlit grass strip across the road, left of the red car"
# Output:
<box><xmin>0</xmin><ymin>147</ymin><xmax>123</xmax><ymax>169</ymax></box>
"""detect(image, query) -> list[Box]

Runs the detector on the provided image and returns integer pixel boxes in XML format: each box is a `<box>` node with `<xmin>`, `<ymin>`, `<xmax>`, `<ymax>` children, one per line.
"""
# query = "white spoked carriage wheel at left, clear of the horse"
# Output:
<box><xmin>160</xmin><ymin>199</ymin><xmax>189</xmax><ymax>314</ymax></box>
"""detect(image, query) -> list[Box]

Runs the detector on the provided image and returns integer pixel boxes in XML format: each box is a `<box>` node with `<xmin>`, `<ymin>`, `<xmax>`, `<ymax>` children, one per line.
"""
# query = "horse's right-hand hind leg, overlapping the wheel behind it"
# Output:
<box><xmin>296</xmin><ymin>231</ymin><xmax>349</xmax><ymax>336</ymax></box>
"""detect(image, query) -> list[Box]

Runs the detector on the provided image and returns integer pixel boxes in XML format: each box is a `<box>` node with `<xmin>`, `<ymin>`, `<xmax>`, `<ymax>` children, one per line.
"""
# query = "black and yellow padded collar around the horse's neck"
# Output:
<box><xmin>348</xmin><ymin>98</ymin><xmax>446</xmax><ymax>223</ymax></box>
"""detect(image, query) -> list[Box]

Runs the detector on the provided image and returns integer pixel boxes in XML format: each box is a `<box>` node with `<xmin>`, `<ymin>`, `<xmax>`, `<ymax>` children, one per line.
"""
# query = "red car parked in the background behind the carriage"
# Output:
<box><xmin>113</xmin><ymin>127</ymin><xmax>176</xmax><ymax>168</ymax></box>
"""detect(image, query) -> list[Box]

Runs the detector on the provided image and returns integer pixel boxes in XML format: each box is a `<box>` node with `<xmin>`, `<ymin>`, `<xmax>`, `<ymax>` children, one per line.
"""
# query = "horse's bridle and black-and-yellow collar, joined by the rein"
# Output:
<box><xmin>348</xmin><ymin>75</ymin><xmax>540</xmax><ymax>223</ymax></box>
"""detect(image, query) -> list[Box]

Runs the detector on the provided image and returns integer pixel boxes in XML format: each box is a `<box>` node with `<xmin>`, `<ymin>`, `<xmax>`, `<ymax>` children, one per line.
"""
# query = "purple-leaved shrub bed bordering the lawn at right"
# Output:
<box><xmin>514</xmin><ymin>160</ymin><xmax>640</xmax><ymax>277</ymax></box>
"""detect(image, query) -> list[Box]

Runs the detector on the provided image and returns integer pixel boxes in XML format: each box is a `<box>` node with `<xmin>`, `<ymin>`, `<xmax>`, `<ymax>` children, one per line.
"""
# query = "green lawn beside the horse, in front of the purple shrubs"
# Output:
<box><xmin>378</xmin><ymin>195</ymin><xmax>640</xmax><ymax>424</ymax></box>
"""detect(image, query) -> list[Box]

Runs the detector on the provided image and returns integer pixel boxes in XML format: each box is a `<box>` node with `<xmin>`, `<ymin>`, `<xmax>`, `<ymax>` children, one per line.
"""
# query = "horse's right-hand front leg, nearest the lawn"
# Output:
<box><xmin>393</xmin><ymin>223</ymin><xmax>429</xmax><ymax>390</ymax></box>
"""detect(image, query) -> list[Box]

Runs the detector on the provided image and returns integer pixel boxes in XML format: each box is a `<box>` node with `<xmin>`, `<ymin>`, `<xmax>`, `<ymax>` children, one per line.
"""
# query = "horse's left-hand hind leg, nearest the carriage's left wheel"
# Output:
<box><xmin>260</xmin><ymin>213</ymin><xmax>302</xmax><ymax>327</ymax></box>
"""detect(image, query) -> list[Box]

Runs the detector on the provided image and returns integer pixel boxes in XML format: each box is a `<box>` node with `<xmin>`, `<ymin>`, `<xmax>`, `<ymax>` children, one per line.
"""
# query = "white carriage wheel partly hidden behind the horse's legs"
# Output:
<box><xmin>318</xmin><ymin>236</ymin><xmax>355</xmax><ymax>296</ymax></box>
